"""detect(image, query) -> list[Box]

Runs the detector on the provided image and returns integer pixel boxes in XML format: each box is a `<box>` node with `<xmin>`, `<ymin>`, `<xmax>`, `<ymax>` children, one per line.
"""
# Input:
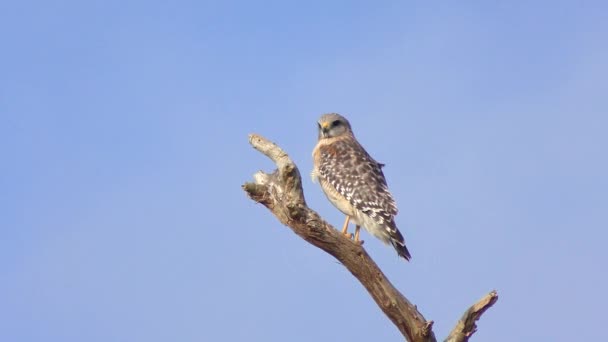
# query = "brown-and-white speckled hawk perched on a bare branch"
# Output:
<box><xmin>311</xmin><ymin>113</ymin><xmax>411</xmax><ymax>261</ymax></box>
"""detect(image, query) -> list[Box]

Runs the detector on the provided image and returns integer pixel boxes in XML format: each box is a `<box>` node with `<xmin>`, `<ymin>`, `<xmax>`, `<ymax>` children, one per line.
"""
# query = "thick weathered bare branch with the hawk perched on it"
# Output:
<box><xmin>243</xmin><ymin>134</ymin><xmax>495</xmax><ymax>342</ymax></box>
